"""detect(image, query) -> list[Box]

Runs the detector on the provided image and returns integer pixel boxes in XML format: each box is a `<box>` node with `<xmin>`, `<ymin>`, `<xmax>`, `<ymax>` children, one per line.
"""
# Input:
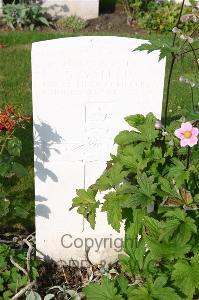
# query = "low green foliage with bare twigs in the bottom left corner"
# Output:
<box><xmin>0</xmin><ymin>244</ymin><xmax>39</xmax><ymax>300</ymax></box>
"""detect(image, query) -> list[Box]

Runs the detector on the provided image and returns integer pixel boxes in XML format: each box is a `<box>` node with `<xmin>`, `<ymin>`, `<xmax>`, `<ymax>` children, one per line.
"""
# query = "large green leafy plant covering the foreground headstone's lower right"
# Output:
<box><xmin>73</xmin><ymin>113</ymin><xmax>199</xmax><ymax>300</ymax></box>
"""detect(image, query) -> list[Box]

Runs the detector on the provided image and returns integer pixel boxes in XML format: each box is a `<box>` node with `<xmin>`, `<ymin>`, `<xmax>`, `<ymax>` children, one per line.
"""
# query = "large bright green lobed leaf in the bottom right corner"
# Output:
<box><xmin>172</xmin><ymin>255</ymin><xmax>199</xmax><ymax>299</ymax></box>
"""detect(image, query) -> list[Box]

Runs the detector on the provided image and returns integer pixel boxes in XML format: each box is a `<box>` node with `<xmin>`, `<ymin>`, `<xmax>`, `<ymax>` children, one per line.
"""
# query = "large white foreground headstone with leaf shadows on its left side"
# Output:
<box><xmin>32</xmin><ymin>36</ymin><xmax>165</xmax><ymax>264</ymax></box>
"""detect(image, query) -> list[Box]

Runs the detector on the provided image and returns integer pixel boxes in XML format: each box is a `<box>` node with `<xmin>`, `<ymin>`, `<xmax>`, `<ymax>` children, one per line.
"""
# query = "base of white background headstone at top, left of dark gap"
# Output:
<box><xmin>42</xmin><ymin>0</ymin><xmax>99</xmax><ymax>20</ymax></box>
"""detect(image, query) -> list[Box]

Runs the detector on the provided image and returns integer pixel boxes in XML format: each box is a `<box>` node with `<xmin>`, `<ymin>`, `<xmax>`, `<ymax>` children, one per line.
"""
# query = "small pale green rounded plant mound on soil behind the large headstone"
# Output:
<box><xmin>57</xmin><ymin>15</ymin><xmax>87</xmax><ymax>31</ymax></box>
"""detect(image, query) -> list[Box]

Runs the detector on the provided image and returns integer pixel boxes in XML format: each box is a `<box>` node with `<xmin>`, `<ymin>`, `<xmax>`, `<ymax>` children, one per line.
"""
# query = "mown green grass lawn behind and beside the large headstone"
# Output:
<box><xmin>0</xmin><ymin>32</ymin><xmax>199</xmax><ymax>230</ymax></box>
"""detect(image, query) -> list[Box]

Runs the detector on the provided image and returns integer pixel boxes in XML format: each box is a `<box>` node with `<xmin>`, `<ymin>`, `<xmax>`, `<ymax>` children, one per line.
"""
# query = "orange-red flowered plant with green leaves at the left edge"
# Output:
<box><xmin>0</xmin><ymin>105</ymin><xmax>29</xmax><ymax>221</ymax></box>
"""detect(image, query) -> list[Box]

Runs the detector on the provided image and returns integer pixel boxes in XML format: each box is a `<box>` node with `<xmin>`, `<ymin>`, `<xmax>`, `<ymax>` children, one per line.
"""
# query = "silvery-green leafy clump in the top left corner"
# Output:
<box><xmin>3</xmin><ymin>3</ymin><xmax>50</xmax><ymax>30</ymax></box>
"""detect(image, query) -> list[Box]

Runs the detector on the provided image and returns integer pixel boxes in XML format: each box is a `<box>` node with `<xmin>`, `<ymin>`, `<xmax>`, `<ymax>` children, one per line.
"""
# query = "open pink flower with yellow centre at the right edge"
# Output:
<box><xmin>175</xmin><ymin>122</ymin><xmax>199</xmax><ymax>147</ymax></box>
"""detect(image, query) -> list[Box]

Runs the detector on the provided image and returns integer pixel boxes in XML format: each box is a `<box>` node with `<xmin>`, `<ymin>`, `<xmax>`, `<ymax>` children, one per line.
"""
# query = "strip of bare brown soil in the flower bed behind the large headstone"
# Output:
<box><xmin>0</xmin><ymin>6</ymin><xmax>146</xmax><ymax>35</ymax></box>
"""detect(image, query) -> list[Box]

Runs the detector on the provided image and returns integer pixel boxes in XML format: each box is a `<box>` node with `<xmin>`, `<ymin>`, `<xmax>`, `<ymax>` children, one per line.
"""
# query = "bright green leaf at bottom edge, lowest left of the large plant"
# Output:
<box><xmin>83</xmin><ymin>277</ymin><xmax>123</xmax><ymax>300</ymax></box>
